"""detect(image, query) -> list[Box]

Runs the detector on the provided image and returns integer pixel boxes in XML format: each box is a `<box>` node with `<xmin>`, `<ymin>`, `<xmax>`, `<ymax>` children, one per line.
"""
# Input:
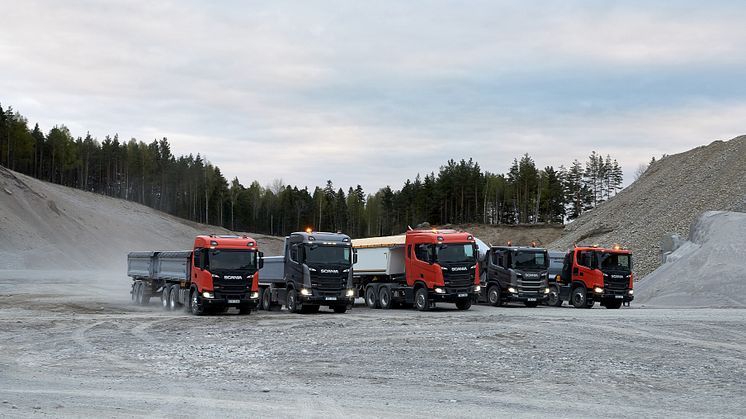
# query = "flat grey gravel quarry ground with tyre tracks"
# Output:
<box><xmin>0</xmin><ymin>271</ymin><xmax>746</xmax><ymax>417</ymax></box>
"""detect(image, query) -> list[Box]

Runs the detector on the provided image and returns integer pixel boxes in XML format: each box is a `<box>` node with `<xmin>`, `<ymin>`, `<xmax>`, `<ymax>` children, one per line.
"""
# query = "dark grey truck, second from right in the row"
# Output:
<box><xmin>480</xmin><ymin>245</ymin><xmax>549</xmax><ymax>307</ymax></box>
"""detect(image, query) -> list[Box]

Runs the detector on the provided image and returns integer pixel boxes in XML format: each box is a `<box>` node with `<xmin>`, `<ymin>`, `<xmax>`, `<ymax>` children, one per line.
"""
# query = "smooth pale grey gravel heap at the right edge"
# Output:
<box><xmin>635</xmin><ymin>211</ymin><xmax>746</xmax><ymax>308</ymax></box>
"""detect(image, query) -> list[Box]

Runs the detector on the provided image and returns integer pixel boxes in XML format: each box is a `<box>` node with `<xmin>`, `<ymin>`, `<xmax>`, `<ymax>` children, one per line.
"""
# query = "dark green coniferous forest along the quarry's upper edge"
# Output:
<box><xmin>0</xmin><ymin>105</ymin><xmax>623</xmax><ymax>237</ymax></box>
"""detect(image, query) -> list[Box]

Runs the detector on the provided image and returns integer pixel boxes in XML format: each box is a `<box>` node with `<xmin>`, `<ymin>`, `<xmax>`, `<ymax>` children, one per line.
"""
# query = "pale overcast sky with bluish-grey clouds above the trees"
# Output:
<box><xmin>0</xmin><ymin>0</ymin><xmax>746</xmax><ymax>192</ymax></box>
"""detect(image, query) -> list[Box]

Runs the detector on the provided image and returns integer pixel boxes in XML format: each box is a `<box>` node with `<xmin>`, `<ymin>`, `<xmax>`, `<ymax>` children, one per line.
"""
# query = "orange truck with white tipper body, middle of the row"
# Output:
<box><xmin>352</xmin><ymin>229</ymin><xmax>480</xmax><ymax>311</ymax></box>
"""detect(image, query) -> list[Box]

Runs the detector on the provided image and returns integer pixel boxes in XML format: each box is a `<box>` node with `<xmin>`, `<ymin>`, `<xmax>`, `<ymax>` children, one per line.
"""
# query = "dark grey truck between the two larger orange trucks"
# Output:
<box><xmin>259</xmin><ymin>231</ymin><xmax>356</xmax><ymax>313</ymax></box>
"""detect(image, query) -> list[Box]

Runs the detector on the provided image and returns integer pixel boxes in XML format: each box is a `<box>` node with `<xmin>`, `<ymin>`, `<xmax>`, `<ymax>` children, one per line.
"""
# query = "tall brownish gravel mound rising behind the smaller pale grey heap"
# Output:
<box><xmin>549</xmin><ymin>136</ymin><xmax>746</xmax><ymax>278</ymax></box>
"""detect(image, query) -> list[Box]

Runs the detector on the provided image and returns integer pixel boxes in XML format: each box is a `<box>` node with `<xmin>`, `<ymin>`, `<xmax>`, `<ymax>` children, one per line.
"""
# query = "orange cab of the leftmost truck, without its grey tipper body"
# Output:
<box><xmin>186</xmin><ymin>234</ymin><xmax>263</xmax><ymax>314</ymax></box>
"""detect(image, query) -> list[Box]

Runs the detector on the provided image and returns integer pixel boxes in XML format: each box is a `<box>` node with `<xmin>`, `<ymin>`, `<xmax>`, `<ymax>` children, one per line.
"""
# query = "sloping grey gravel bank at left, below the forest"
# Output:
<box><xmin>0</xmin><ymin>166</ymin><xmax>282</xmax><ymax>275</ymax></box>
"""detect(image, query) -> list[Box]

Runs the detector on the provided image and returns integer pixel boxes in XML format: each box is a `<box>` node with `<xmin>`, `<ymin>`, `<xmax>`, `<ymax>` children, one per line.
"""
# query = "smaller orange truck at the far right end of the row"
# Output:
<box><xmin>556</xmin><ymin>245</ymin><xmax>634</xmax><ymax>309</ymax></box>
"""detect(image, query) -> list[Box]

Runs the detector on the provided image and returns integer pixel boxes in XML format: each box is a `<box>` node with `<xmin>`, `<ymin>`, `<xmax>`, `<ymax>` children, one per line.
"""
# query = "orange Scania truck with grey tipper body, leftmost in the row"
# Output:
<box><xmin>127</xmin><ymin>234</ymin><xmax>264</xmax><ymax>315</ymax></box>
